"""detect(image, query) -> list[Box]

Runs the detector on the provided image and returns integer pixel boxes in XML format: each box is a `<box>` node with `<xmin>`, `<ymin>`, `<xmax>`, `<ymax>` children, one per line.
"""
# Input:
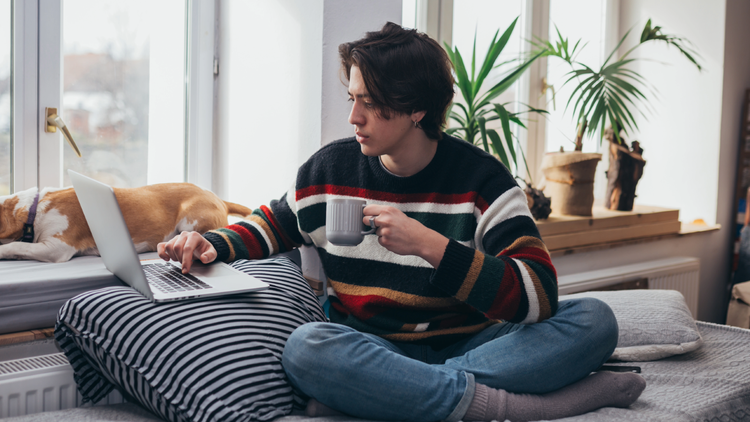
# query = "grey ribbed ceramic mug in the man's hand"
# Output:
<box><xmin>326</xmin><ymin>198</ymin><xmax>375</xmax><ymax>246</ymax></box>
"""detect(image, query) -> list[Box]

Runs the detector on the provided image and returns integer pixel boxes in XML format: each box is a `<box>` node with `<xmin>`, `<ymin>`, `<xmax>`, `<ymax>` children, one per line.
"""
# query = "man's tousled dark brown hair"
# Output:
<box><xmin>339</xmin><ymin>22</ymin><xmax>453</xmax><ymax>139</ymax></box>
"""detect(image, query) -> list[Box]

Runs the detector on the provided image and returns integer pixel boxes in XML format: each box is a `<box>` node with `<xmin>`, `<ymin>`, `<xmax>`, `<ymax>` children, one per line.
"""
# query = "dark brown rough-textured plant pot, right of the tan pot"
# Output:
<box><xmin>604</xmin><ymin>142</ymin><xmax>646</xmax><ymax>211</ymax></box>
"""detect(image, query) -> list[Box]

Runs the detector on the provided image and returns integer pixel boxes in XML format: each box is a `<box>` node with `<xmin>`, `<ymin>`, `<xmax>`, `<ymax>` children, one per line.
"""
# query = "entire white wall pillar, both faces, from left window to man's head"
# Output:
<box><xmin>214</xmin><ymin>0</ymin><xmax>401</xmax><ymax>204</ymax></box>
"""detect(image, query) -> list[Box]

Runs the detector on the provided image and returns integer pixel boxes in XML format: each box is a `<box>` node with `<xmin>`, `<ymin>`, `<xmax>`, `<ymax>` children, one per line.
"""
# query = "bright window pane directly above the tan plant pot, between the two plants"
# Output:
<box><xmin>546</xmin><ymin>0</ymin><xmax>605</xmax><ymax>152</ymax></box>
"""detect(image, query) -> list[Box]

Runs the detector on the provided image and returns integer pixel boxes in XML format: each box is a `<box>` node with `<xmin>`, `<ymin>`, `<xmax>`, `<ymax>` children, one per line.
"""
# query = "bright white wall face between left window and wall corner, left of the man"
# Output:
<box><xmin>216</xmin><ymin>0</ymin><xmax>323</xmax><ymax>208</ymax></box>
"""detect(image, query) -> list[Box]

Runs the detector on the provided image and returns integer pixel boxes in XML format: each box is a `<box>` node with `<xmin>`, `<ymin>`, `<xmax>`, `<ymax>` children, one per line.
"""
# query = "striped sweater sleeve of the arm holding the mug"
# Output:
<box><xmin>431</xmin><ymin>186</ymin><xmax>557</xmax><ymax>324</ymax></box>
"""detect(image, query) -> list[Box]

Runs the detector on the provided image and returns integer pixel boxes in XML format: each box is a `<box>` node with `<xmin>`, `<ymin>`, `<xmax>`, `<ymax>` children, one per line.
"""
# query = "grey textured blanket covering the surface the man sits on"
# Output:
<box><xmin>6</xmin><ymin>322</ymin><xmax>750</xmax><ymax>422</ymax></box>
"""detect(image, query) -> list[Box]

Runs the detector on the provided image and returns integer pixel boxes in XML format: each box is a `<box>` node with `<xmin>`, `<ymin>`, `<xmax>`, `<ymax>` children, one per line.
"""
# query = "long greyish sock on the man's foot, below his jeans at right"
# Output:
<box><xmin>464</xmin><ymin>372</ymin><xmax>646</xmax><ymax>422</ymax></box>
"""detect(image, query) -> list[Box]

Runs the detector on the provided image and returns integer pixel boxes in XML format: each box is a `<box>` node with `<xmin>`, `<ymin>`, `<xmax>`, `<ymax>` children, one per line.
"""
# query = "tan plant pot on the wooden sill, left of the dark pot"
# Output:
<box><xmin>542</xmin><ymin>151</ymin><xmax>602</xmax><ymax>216</ymax></box>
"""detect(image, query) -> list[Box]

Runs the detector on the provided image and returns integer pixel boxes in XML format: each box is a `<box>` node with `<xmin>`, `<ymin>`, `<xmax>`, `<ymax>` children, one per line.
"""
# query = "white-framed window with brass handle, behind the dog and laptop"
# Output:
<box><xmin>8</xmin><ymin>0</ymin><xmax>215</xmax><ymax>194</ymax></box>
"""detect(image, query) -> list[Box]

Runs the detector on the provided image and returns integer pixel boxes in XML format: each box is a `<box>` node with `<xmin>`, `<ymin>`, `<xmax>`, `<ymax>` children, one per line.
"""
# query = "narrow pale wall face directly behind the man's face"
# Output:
<box><xmin>321</xmin><ymin>0</ymin><xmax>401</xmax><ymax>144</ymax></box>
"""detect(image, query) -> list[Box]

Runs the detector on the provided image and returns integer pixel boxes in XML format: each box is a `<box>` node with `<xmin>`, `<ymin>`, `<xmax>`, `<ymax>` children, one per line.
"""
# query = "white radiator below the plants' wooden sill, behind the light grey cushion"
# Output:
<box><xmin>557</xmin><ymin>257</ymin><xmax>700</xmax><ymax>318</ymax></box>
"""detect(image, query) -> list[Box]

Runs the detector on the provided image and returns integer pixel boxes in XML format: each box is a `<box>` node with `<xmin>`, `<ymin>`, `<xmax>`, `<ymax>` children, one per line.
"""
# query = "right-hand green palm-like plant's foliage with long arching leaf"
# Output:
<box><xmin>533</xmin><ymin>19</ymin><xmax>702</xmax><ymax>151</ymax></box>
